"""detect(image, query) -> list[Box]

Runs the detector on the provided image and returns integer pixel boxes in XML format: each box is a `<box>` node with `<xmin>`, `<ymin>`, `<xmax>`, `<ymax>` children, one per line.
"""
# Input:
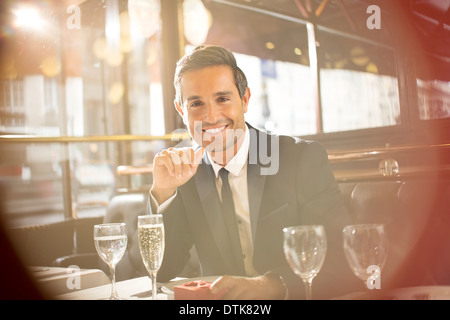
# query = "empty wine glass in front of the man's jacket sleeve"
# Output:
<box><xmin>283</xmin><ymin>225</ymin><xmax>327</xmax><ymax>300</ymax></box>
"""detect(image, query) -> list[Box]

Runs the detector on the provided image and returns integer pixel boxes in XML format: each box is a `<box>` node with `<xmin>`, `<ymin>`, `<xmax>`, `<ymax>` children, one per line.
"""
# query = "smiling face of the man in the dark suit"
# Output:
<box><xmin>175</xmin><ymin>65</ymin><xmax>250</xmax><ymax>154</ymax></box>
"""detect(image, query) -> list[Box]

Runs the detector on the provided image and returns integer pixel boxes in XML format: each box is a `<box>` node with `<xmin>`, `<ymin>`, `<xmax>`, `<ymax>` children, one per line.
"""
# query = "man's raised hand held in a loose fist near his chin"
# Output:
<box><xmin>151</xmin><ymin>148</ymin><xmax>204</xmax><ymax>204</ymax></box>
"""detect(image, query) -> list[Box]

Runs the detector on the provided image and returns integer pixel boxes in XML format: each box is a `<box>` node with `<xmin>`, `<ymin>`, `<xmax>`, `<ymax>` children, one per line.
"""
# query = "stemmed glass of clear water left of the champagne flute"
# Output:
<box><xmin>94</xmin><ymin>223</ymin><xmax>128</xmax><ymax>300</ymax></box>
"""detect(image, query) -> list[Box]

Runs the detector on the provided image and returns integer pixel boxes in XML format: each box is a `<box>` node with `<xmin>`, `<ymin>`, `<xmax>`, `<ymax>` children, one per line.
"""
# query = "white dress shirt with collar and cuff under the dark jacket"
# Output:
<box><xmin>150</xmin><ymin>125</ymin><xmax>258</xmax><ymax>276</ymax></box>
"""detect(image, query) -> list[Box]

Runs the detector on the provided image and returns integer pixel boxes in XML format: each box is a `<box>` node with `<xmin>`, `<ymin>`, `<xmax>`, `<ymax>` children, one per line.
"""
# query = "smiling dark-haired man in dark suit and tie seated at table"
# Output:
<box><xmin>150</xmin><ymin>46</ymin><xmax>354</xmax><ymax>299</ymax></box>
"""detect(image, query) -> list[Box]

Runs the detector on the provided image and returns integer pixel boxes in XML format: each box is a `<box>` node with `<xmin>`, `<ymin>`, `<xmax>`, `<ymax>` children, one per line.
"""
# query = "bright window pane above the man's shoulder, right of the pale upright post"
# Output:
<box><xmin>318</xmin><ymin>31</ymin><xmax>401</xmax><ymax>132</ymax></box>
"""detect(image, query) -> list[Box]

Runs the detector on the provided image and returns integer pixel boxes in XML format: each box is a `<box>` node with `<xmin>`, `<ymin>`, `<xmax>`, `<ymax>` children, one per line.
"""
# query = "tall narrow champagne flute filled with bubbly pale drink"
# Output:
<box><xmin>138</xmin><ymin>214</ymin><xmax>165</xmax><ymax>300</ymax></box>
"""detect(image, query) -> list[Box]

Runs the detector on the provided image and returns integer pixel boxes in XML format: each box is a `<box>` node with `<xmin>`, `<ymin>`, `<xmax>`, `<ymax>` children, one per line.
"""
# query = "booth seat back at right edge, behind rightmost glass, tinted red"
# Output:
<box><xmin>339</xmin><ymin>176</ymin><xmax>450</xmax><ymax>288</ymax></box>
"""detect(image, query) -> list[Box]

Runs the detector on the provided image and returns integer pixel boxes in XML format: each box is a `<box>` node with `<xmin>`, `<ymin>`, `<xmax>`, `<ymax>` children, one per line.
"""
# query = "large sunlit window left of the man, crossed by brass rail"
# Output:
<box><xmin>0</xmin><ymin>0</ymin><xmax>165</xmax><ymax>225</ymax></box>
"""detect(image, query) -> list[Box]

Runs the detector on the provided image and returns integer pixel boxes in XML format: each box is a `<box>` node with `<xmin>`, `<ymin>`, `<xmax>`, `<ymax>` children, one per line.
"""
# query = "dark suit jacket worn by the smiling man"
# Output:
<box><xmin>153</xmin><ymin>126</ymin><xmax>356</xmax><ymax>298</ymax></box>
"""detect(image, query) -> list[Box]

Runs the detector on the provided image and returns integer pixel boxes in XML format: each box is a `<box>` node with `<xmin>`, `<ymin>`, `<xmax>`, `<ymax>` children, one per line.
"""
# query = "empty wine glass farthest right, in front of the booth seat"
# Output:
<box><xmin>343</xmin><ymin>224</ymin><xmax>388</xmax><ymax>289</ymax></box>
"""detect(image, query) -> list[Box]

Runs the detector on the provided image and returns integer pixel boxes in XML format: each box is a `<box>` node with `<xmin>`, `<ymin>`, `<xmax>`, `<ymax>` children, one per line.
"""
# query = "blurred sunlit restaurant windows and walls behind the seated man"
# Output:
<box><xmin>0</xmin><ymin>0</ymin><xmax>450</xmax><ymax>298</ymax></box>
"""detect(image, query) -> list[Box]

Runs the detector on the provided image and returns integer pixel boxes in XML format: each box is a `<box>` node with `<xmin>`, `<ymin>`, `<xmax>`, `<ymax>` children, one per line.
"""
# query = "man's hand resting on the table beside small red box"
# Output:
<box><xmin>210</xmin><ymin>275</ymin><xmax>286</xmax><ymax>300</ymax></box>
